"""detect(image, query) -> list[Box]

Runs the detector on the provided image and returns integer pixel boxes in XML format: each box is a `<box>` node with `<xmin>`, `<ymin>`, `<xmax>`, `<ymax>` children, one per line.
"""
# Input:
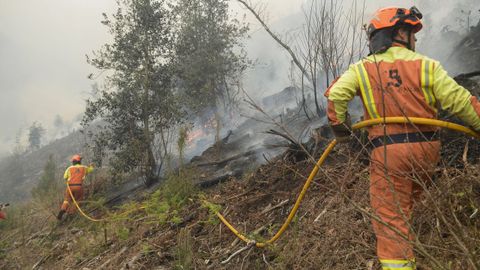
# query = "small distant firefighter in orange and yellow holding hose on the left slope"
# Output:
<box><xmin>57</xmin><ymin>155</ymin><xmax>93</xmax><ymax>220</ymax></box>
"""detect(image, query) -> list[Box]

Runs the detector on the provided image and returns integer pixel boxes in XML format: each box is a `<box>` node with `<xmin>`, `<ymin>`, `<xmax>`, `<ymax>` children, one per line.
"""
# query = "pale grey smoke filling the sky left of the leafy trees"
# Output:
<box><xmin>0</xmin><ymin>0</ymin><xmax>115</xmax><ymax>153</ymax></box>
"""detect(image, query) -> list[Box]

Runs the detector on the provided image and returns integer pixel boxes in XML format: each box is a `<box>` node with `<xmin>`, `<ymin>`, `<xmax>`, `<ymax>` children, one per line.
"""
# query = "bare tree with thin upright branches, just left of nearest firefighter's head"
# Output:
<box><xmin>237</xmin><ymin>0</ymin><xmax>366</xmax><ymax>117</ymax></box>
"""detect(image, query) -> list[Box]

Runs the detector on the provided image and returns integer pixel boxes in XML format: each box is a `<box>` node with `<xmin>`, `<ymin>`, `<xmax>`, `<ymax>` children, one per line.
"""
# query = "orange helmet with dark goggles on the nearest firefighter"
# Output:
<box><xmin>367</xmin><ymin>6</ymin><xmax>423</xmax><ymax>38</ymax></box>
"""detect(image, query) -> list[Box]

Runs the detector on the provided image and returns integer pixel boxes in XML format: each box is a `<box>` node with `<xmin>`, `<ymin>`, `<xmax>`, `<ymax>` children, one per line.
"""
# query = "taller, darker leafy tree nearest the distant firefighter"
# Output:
<box><xmin>83</xmin><ymin>0</ymin><xmax>182</xmax><ymax>185</ymax></box>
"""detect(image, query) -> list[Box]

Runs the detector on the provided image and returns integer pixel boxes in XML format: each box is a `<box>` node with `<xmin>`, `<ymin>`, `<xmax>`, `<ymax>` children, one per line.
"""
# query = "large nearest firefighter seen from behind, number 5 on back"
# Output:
<box><xmin>325</xmin><ymin>7</ymin><xmax>480</xmax><ymax>270</ymax></box>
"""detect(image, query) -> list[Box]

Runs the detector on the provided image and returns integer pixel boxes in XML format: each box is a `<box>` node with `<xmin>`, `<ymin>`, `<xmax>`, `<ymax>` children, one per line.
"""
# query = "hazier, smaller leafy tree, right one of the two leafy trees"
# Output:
<box><xmin>175</xmin><ymin>0</ymin><xmax>248</xmax><ymax>137</ymax></box>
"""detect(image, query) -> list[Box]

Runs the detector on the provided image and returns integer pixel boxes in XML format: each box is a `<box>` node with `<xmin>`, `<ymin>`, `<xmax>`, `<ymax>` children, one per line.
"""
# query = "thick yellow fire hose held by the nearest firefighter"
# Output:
<box><xmin>215</xmin><ymin>117</ymin><xmax>480</xmax><ymax>248</ymax></box>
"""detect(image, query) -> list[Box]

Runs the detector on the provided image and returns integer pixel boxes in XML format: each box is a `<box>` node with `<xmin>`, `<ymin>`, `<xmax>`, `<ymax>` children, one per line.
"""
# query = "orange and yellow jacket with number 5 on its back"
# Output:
<box><xmin>325</xmin><ymin>47</ymin><xmax>480</xmax><ymax>137</ymax></box>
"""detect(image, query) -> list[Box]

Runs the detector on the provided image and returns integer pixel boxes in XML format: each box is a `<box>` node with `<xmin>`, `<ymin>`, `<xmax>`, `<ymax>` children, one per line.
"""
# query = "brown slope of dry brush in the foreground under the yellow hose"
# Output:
<box><xmin>0</xmin><ymin>131</ymin><xmax>480</xmax><ymax>270</ymax></box>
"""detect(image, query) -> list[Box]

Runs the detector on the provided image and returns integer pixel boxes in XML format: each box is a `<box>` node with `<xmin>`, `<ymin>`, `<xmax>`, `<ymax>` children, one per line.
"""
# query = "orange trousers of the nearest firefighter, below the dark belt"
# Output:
<box><xmin>370</xmin><ymin>141</ymin><xmax>440</xmax><ymax>260</ymax></box>
